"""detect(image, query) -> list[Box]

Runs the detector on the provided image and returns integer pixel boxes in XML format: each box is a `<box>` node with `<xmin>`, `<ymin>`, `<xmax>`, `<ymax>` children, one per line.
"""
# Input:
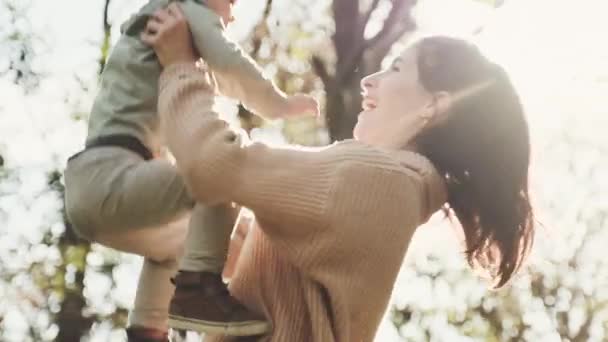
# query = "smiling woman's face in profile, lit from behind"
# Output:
<box><xmin>353</xmin><ymin>46</ymin><xmax>432</xmax><ymax>147</ymax></box>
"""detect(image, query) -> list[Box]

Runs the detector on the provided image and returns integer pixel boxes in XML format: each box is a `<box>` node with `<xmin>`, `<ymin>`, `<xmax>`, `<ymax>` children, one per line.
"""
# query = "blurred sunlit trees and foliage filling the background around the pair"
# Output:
<box><xmin>0</xmin><ymin>0</ymin><xmax>608</xmax><ymax>341</ymax></box>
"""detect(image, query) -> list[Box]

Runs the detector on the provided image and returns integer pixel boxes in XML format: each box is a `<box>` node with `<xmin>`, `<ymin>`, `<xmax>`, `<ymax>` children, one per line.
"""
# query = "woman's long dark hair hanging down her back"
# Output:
<box><xmin>414</xmin><ymin>36</ymin><xmax>534</xmax><ymax>288</ymax></box>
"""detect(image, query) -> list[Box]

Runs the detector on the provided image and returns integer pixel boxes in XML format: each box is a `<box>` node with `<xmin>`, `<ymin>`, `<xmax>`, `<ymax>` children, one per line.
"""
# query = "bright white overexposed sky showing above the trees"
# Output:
<box><xmin>0</xmin><ymin>0</ymin><xmax>608</xmax><ymax>167</ymax></box>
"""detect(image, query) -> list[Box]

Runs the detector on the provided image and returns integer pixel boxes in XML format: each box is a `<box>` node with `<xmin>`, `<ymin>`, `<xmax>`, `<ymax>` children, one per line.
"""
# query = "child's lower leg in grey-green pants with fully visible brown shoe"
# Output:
<box><xmin>169</xmin><ymin>205</ymin><xmax>270</xmax><ymax>336</ymax></box>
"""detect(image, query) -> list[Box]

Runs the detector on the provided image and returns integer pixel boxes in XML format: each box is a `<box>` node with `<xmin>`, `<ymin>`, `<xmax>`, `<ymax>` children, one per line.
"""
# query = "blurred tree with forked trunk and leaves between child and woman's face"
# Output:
<box><xmin>233</xmin><ymin>0</ymin><xmax>416</xmax><ymax>143</ymax></box>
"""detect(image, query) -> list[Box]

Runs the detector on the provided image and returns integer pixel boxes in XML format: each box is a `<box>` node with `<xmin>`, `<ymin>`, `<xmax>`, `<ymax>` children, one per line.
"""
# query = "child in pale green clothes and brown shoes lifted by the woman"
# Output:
<box><xmin>65</xmin><ymin>0</ymin><xmax>318</xmax><ymax>340</ymax></box>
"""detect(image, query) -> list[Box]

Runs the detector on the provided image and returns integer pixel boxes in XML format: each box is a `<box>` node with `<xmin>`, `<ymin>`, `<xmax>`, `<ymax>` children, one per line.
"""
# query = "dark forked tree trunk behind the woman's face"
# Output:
<box><xmin>312</xmin><ymin>0</ymin><xmax>416</xmax><ymax>141</ymax></box>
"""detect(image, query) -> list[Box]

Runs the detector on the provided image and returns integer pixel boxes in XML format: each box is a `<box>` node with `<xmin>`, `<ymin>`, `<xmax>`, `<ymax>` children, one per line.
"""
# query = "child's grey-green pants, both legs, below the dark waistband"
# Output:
<box><xmin>65</xmin><ymin>147</ymin><xmax>235</xmax><ymax>329</ymax></box>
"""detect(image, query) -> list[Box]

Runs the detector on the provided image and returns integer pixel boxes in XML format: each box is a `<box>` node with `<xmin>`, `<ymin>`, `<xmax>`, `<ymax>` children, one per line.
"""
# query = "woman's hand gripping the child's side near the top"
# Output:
<box><xmin>141</xmin><ymin>3</ymin><xmax>198</xmax><ymax>67</ymax></box>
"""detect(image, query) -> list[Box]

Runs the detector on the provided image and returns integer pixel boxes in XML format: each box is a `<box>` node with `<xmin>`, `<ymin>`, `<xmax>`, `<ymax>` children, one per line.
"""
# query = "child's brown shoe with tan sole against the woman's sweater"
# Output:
<box><xmin>169</xmin><ymin>272</ymin><xmax>270</xmax><ymax>336</ymax></box>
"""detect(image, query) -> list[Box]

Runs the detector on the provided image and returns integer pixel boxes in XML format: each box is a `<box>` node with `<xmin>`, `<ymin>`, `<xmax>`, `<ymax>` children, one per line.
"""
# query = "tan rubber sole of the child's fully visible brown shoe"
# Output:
<box><xmin>169</xmin><ymin>315</ymin><xmax>270</xmax><ymax>336</ymax></box>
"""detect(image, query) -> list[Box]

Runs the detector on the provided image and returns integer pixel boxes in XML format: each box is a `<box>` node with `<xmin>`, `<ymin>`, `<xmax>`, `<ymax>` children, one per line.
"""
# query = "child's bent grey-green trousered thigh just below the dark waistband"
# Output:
<box><xmin>65</xmin><ymin>147</ymin><xmax>194</xmax><ymax>240</ymax></box>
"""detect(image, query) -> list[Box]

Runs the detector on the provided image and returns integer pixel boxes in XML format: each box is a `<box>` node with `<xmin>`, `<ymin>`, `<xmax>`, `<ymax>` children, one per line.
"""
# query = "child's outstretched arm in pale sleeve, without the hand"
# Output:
<box><xmin>180</xmin><ymin>1</ymin><xmax>300</xmax><ymax>119</ymax></box>
